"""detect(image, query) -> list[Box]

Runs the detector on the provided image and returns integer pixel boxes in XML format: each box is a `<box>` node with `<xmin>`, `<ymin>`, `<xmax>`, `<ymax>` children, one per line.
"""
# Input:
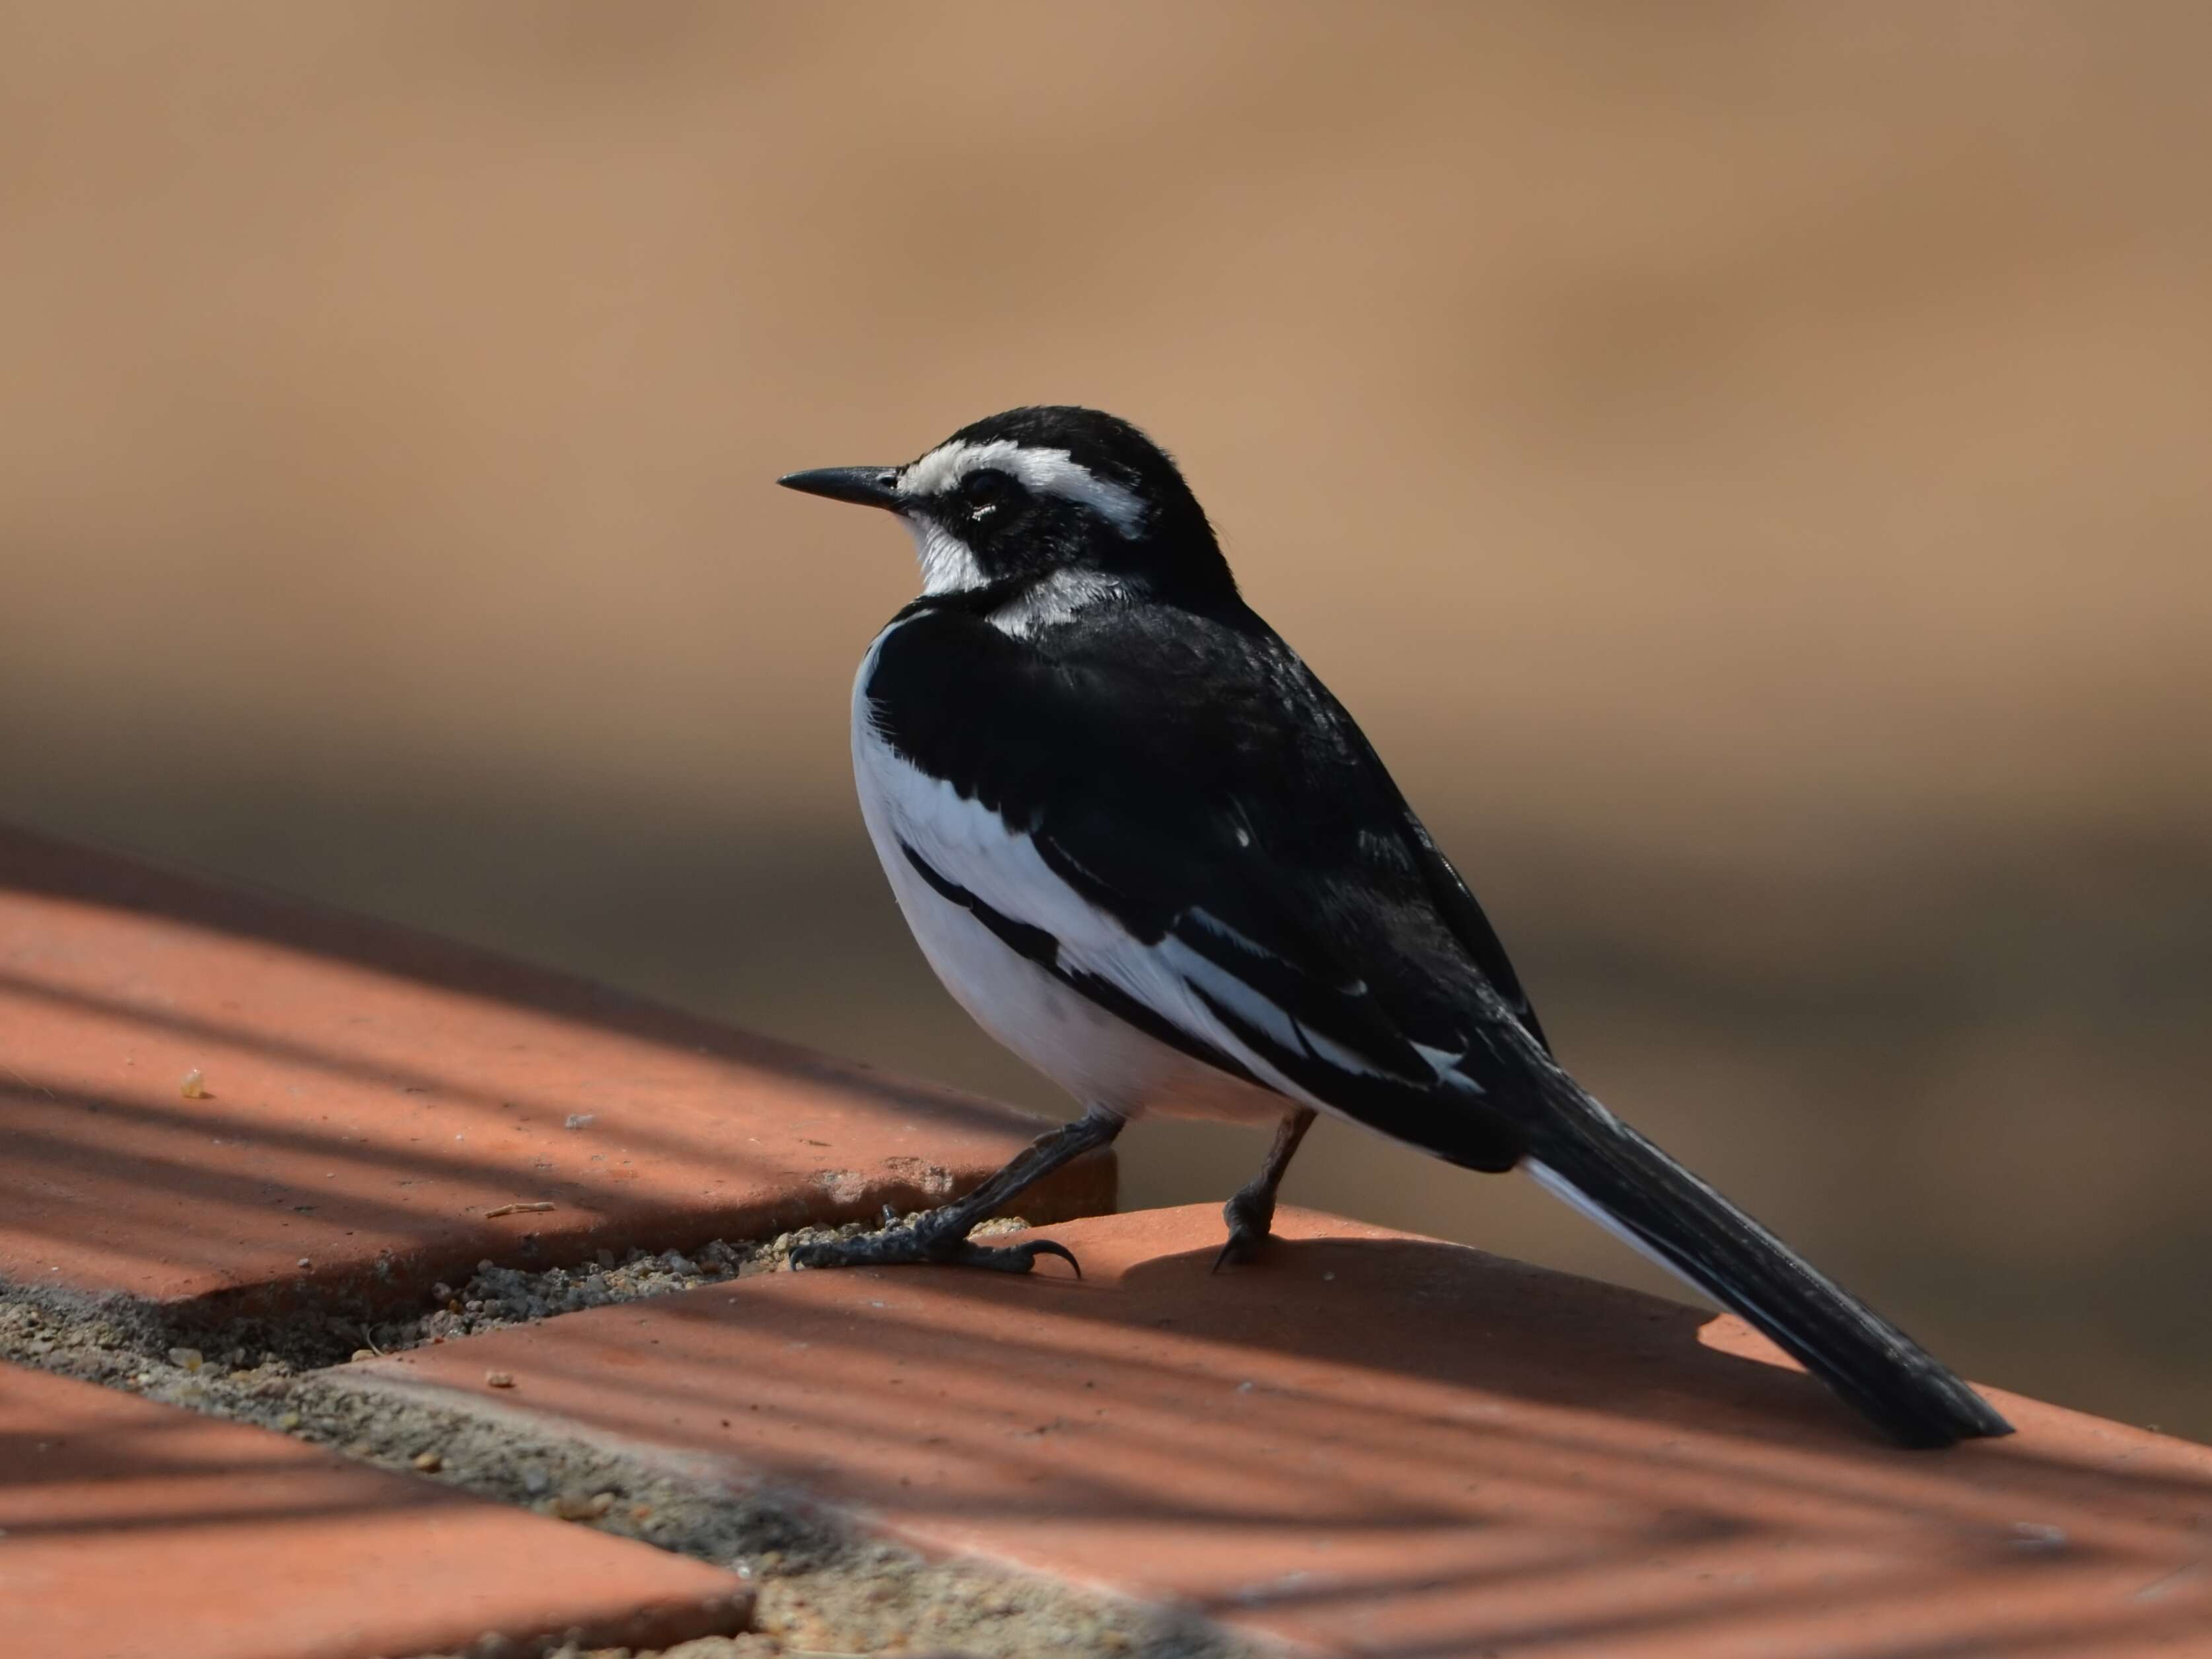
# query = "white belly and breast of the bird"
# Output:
<box><xmin>851</xmin><ymin>650</ymin><xmax>1289</xmax><ymax>1124</ymax></box>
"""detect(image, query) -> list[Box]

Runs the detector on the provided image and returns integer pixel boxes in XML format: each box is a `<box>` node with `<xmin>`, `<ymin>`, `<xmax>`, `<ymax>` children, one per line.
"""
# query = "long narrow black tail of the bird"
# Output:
<box><xmin>1524</xmin><ymin>1066</ymin><xmax>2013</xmax><ymax>1447</ymax></box>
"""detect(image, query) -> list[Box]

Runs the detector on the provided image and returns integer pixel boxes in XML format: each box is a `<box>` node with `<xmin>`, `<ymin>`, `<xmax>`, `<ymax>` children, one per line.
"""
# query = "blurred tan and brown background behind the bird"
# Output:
<box><xmin>0</xmin><ymin>0</ymin><xmax>2212</xmax><ymax>1438</ymax></box>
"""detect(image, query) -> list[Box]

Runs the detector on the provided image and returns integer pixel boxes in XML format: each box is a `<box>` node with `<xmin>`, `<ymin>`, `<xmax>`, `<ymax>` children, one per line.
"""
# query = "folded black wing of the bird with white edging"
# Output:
<box><xmin>878</xmin><ymin>597</ymin><xmax>1533</xmax><ymax>1170</ymax></box>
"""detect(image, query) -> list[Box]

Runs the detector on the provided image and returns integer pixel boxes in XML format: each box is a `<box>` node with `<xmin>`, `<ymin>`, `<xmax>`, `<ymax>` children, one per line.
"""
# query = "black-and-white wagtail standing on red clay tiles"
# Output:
<box><xmin>776</xmin><ymin>405</ymin><xmax>2011</xmax><ymax>1447</ymax></box>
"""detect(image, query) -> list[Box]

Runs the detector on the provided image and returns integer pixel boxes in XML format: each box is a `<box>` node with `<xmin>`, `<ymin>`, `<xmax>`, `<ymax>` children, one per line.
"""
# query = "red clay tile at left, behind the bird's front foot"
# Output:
<box><xmin>0</xmin><ymin>830</ymin><xmax>1113</xmax><ymax>1301</ymax></box>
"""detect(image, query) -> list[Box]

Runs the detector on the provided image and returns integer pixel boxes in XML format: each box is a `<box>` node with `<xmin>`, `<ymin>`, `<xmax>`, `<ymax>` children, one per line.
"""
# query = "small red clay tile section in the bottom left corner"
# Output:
<box><xmin>0</xmin><ymin>1367</ymin><xmax>750</xmax><ymax>1659</ymax></box>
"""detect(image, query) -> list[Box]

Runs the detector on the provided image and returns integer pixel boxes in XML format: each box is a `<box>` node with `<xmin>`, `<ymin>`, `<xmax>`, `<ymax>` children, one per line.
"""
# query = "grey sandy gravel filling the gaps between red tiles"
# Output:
<box><xmin>0</xmin><ymin>1221</ymin><xmax>1256</xmax><ymax>1659</ymax></box>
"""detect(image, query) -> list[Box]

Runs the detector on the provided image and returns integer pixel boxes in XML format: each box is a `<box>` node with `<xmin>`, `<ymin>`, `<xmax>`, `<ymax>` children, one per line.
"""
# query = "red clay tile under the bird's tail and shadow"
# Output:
<box><xmin>349</xmin><ymin>1208</ymin><xmax>2212</xmax><ymax>1659</ymax></box>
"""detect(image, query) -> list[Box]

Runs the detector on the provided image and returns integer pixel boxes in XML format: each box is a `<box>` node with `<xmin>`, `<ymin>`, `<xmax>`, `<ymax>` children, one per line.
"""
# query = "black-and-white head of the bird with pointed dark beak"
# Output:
<box><xmin>776</xmin><ymin>405</ymin><xmax>1236</xmax><ymax>602</ymax></box>
